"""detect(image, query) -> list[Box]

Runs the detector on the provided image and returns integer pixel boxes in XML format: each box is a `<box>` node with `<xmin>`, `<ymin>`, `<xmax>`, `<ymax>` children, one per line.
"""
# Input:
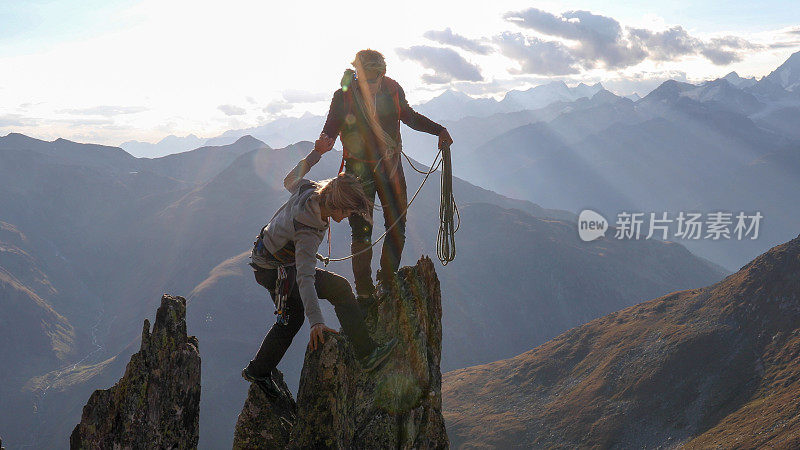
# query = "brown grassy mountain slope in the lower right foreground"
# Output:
<box><xmin>443</xmin><ymin>236</ymin><xmax>800</xmax><ymax>448</ymax></box>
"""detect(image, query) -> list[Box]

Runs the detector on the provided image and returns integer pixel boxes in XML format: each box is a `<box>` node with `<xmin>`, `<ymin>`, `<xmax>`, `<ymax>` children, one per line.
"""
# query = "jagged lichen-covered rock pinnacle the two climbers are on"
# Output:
<box><xmin>233</xmin><ymin>257</ymin><xmax>449</xmax><ymax>449</ymax></box>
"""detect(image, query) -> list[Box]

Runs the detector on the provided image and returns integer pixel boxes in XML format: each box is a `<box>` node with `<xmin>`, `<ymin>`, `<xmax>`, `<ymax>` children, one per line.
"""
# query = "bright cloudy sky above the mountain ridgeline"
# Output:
<box><xmin>0</xmin><ymin>0</ymin><xmax>800</xmax><ymax>145</ymax></box>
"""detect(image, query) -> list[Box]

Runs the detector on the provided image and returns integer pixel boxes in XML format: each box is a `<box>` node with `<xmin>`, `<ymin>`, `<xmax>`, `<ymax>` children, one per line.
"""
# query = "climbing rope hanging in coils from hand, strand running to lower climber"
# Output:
<box><xmin>317</xmin><ymin>146</ymin><xmax>461</xmax><ymax>266</ymax></box>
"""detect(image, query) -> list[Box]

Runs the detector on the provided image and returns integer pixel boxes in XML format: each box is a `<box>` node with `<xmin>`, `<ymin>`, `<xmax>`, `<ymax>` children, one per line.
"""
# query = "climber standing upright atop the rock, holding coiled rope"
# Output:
<box><xmin>314</xmin><ymin>49</ymin><xmax>453</xmax><ymax>297</ymax></box>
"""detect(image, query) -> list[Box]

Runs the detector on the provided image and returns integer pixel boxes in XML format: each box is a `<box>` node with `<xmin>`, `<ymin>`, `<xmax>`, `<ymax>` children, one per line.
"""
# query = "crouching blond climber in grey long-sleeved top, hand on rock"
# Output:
<box><xmin>242</xmin><ymin>145</ymin><xmax>396</xmax><ymax>397</ymax></box>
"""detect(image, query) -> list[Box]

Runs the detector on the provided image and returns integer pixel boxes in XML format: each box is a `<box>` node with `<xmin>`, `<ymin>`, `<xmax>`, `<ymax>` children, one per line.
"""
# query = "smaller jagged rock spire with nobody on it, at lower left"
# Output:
<box><xmin>70</xmin><ymin>294</ymin><xmax>200</xmax><ymax>449</ymax></box>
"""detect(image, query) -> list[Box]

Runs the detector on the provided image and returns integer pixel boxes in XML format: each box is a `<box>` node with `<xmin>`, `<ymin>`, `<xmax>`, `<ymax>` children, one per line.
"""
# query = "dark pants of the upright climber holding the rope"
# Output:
<box><xmin>345</xmin><ymin>156</ymin><xmax>408</xmax><ymax>295</ymax></box>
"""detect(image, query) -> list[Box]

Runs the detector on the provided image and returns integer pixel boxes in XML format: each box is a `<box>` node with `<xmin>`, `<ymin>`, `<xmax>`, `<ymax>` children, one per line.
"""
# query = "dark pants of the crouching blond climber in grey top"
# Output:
<box><xmin>249</xmin><ymin>266</ymin><xmax>375</xmax><ymax>377</ymax></box>
